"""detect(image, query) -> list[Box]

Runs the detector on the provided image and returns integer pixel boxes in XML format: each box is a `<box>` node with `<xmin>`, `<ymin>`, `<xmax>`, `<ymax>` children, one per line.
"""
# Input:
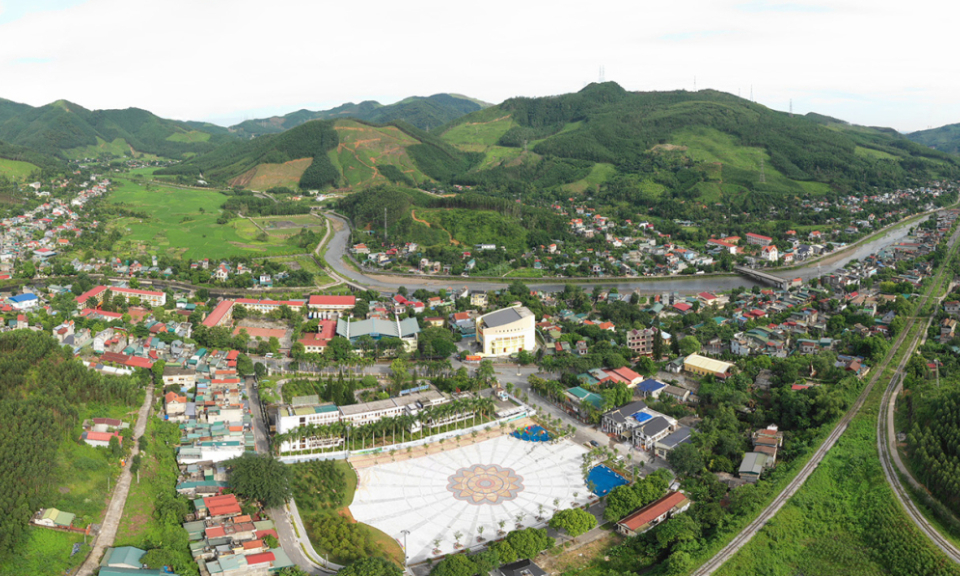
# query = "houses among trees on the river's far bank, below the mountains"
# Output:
<box><xmin>351</xmin><ymin>182</ymin><xmax>955</xmax><ymax>278</ymax></box>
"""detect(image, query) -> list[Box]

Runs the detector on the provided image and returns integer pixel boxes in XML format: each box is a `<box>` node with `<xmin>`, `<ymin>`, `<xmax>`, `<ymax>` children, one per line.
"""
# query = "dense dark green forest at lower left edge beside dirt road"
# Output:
<box><xmin>0</xmin><ymin>330</ymin><xmax>139</xmax><ymax>554</ymax></box>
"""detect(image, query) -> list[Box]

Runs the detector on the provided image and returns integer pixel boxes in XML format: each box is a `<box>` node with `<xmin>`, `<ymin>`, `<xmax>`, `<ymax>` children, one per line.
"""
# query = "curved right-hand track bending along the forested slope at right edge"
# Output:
<box><xmin>877</xmin><ymin>227</ymin><xmax>960</xmax><ymax>563</ymax></box>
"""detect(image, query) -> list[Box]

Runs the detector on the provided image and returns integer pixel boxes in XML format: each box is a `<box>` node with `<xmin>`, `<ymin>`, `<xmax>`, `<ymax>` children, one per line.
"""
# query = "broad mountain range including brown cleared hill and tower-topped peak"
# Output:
<box><xmin>157</xmin><ymin>82</ymin><xmax>960</xmax><ymax>204</ymax></box>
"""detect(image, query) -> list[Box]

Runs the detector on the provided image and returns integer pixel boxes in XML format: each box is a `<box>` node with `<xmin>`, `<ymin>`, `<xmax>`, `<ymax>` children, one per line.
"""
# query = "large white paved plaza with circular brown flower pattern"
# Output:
<box><xmin>350</xmin><ymin>436</ymin><xmax>588</xmax><ymax>564</ymax></box>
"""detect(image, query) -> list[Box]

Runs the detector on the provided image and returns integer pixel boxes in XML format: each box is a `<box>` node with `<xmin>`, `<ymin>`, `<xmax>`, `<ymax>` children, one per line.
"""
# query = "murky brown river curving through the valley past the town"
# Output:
<box><xmin>321</xmin><ymin>213</ymin><xmax>929</xmax><ymax>294</ymax></box>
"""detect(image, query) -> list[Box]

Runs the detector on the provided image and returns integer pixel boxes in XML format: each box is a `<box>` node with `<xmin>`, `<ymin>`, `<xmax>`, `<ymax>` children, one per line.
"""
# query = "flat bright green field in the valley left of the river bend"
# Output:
<box><xmin>110</xmin><ymin>180</ymin><xmax>302</xmax><ymax>259</ymax></box>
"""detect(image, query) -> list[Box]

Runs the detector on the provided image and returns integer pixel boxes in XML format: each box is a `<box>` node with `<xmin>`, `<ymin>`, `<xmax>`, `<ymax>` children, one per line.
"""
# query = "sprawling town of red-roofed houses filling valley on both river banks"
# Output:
<box><xmin>0</xmin><ymin>166</ymin><xmax>960</xmax><ymax>576</ymax></box>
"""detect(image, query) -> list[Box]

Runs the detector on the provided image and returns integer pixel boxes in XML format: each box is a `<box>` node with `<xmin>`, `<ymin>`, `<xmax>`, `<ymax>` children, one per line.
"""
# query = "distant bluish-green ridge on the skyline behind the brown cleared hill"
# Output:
<box><xmin>230</xmin><ymin>94</ymin><xmax>488</xmax><ymax>137</ymax></box>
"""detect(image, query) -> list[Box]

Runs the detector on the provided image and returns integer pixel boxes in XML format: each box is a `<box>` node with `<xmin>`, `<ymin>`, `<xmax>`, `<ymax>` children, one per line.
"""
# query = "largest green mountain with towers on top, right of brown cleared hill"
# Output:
<box><xmin>435</xmin><ymin>82</ymin><xmax>960</xmax><ymax>204</ymax></box>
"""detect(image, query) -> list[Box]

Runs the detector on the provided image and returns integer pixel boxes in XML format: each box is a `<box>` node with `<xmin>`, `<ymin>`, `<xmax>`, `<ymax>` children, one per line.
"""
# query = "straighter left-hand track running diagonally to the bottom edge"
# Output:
<box><xmin>693</xmin><ymin>222</ymin><xmax>960</xmax><ymax>576</ymax></box>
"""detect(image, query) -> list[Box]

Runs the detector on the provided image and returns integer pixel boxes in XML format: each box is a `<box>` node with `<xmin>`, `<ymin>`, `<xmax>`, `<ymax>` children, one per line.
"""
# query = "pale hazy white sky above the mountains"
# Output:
<box><xmin>0</xmin><ymin>0</ymin><xmax>960</xmax><ymax>131</ymax></box>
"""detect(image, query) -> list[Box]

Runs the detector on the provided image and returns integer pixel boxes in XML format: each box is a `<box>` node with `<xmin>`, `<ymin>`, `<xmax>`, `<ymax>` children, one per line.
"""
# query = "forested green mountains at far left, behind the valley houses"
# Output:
<box><xmin>0</xmin><ymin>100</ymin><xmax>234</xmax><ymax>158</ymax></box>
